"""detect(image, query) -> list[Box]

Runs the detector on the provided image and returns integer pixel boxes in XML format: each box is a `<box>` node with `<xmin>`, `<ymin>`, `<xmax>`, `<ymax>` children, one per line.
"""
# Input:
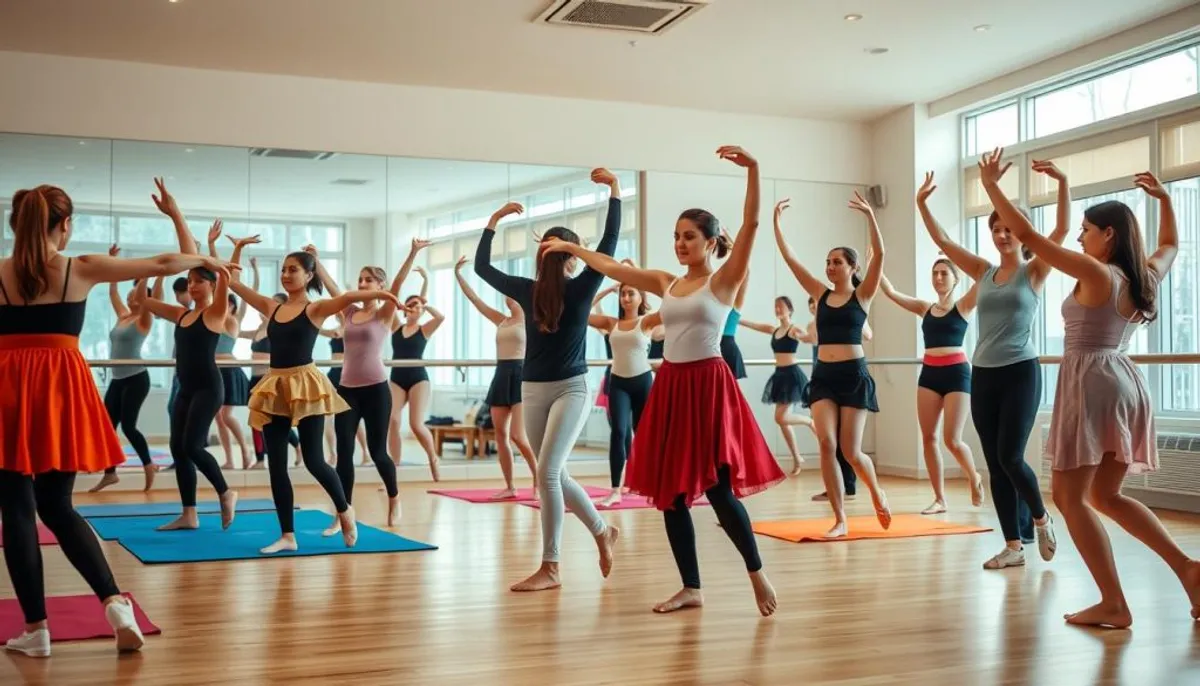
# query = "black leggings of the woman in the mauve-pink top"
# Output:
<box><xmin>334</xmin><ymin>381</ymin><xmax>400</xmax><ymax>503</ymax></box>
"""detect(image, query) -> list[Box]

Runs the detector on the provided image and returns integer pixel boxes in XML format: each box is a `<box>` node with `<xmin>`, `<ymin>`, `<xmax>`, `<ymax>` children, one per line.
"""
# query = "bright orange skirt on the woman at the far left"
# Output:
<box><xmin>0</xmin><ymin>333</ymin><xmax>125</xmax><ymax>475</ymax></box>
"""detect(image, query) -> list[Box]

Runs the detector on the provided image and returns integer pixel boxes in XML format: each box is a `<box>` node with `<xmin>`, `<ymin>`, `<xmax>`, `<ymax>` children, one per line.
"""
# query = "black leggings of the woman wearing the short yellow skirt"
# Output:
<box><xmin>263</xmin><ymin>415</ymin><xmax>350</xmax><ymax>534</ymax></box>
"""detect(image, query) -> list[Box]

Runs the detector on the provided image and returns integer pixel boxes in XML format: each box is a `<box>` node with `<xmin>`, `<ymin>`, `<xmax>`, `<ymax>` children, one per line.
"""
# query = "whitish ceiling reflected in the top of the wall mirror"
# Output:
<box><xmin>0</xmin><ymin>133</ymin><xmax>590</xmax><ymax>218</ymax></box>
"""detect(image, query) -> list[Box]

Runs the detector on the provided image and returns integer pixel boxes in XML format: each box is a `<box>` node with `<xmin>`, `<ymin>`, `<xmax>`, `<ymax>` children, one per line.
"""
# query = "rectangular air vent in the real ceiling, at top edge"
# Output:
<box><xmin>535</xmin><ymin>0</ymin><xmax>713</xmax><ymax>34</ymax></box>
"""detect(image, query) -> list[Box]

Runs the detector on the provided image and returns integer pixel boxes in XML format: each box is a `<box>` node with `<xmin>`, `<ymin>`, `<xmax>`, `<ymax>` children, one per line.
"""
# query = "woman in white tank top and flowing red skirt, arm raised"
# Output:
<box><xmin>546</xmin><ymin>146</ymin><xmax>785</xmax><ymax>616</ymax></box>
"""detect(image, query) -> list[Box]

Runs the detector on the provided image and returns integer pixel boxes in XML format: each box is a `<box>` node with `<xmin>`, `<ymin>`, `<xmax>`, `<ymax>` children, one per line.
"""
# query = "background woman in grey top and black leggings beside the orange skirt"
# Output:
<box><xmin>88</xmin><ymin>246</ymin><xmax>158</xmax><ymax>493</ymax></box>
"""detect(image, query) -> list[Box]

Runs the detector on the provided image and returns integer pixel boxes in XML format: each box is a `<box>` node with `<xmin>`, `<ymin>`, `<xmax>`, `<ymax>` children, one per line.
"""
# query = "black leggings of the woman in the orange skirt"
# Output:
<box><xmin>0</xmin><ymin>470</ymin><xmax>121</xmax><ymax>624</ymax></box>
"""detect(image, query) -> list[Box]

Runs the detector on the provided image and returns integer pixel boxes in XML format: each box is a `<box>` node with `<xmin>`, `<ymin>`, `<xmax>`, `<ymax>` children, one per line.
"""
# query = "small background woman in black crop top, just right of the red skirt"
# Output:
<box><xmin>739</xmin><ymin>295</ymin><xmax>816</xmax><ymax>476</ymax></box>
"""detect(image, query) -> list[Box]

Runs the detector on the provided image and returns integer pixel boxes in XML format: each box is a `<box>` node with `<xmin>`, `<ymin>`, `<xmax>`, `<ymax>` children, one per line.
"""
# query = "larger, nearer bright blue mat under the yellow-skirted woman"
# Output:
<box><xmin>91</xmin><ymin>510</ymin><xmax>437</xmax><ymax>565</ymax></box>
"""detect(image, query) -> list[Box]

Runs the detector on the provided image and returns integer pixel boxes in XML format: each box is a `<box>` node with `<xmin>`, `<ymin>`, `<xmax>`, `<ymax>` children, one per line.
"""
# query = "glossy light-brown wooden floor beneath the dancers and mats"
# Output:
<box><xmin>0</xmin><ymin>471</ymin><xmax>1200</xmax><ymax>686</ymax></box>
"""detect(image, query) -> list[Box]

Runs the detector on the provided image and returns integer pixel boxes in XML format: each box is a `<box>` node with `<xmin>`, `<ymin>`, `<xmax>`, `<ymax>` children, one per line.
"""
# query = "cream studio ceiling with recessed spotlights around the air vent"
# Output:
<box><xmin>0</xmin><ymin>0</ymin><xmax>1195</xmax><ymax>120</ymax></box>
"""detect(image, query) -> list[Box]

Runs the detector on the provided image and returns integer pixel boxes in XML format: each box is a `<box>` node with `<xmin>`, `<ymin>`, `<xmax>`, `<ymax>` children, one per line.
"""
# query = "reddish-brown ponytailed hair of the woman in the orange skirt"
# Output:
<box><xmin>8</xmin><ymin>185</ymin><xmax>74</xmax><ymax>302</ymax></box>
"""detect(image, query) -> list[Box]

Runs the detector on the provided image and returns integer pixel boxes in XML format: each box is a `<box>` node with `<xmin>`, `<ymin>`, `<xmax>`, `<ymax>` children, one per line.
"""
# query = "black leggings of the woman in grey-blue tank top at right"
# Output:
<box><xmin>971</xmin><ymin>360</ymin><xmax>1046</xmax><ymax>541</ymax></box>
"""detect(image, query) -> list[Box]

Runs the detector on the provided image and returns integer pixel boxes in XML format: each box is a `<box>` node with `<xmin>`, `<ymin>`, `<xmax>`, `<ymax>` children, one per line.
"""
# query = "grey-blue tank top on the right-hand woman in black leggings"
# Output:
<box><xmin>972</xmin><ymin>263</ymin><xmax>1040</xmax><ymax>367</ymax></box>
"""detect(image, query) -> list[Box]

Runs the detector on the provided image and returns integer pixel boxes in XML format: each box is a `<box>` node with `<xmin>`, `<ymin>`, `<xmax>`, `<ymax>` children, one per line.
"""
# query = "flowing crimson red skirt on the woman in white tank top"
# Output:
<box><xmin>625</xmin><ymin>357</ymin><xmax>785</xmax><ymax>510</ymax></box>
